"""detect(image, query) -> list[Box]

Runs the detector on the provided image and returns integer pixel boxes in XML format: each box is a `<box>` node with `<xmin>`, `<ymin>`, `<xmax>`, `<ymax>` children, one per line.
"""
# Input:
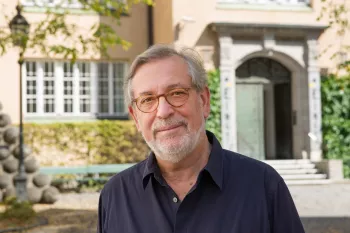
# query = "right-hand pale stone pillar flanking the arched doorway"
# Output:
<box><xmin>307</xmin><ymin>34</ymin><xmax>322</xmax><ymax>161</ymax></box>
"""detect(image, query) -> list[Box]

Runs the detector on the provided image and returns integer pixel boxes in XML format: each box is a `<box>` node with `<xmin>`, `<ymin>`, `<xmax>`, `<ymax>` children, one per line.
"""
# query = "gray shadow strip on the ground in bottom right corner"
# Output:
<box><xmin>301</xmin><ymin>217</ymin><xmax>350</xmax><ymax>233</ymax></box>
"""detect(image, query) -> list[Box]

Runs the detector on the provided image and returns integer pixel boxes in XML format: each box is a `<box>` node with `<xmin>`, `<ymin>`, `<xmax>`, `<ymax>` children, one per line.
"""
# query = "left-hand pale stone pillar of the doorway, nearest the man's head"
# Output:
<box><xmin>219</xmin><ymin>33</ymin><xmax>237</xmax><ymax>151</ymax></box>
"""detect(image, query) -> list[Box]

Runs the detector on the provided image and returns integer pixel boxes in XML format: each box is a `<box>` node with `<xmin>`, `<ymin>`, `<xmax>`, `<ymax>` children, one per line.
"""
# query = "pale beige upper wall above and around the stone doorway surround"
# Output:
<box><xmin>173</xmin><ymin>0</ymin><xmax>350</xmax><ymax>71</ymax></box>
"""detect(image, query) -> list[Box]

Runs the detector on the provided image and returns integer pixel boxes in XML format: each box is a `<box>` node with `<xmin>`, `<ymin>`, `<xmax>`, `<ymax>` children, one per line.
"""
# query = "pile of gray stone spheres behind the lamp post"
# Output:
<box><xmin>0</xmin><ymin>102</ymin><xmax>59</xmax><ymax>204</ymax></box>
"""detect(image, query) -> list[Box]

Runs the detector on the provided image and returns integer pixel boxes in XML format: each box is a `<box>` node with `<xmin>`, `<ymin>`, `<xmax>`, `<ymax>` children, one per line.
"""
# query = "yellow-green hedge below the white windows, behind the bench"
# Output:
<box><xmin>24</xmin><ymin>120</ymin><xmax>149</xmax><ymax>164</ymax></box>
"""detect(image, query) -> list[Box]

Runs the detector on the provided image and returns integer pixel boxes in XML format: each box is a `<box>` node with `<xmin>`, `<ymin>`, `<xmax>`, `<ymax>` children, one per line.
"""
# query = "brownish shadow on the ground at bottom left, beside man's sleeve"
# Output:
<box><xmin>28</xmin><ymin>209</ymin><xmax>97</xmax><ymax>233</ymax></box>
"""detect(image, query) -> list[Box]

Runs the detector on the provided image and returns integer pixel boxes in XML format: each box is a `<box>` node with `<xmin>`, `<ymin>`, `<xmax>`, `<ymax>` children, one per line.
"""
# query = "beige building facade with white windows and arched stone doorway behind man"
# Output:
<box><xmin>0</xmin><ymin>0</ymin><xmax>350</xmax><ymax>161</ymax></box>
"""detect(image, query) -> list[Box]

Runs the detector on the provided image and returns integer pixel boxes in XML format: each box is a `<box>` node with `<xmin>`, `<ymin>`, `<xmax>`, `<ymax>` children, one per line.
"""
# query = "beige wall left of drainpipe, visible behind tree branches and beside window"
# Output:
<box><xmin>0</xmin><ymin>0</ymin><xmax>148</xmax><ymax>123</ymax></box>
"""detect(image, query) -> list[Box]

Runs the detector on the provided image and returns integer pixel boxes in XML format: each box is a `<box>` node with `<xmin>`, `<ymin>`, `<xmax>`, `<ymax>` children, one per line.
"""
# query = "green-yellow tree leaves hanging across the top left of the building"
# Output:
<box><xmin>0</xmin><ymin>0</ymin><xmax>153</xmax><ymax>63</ymax></box>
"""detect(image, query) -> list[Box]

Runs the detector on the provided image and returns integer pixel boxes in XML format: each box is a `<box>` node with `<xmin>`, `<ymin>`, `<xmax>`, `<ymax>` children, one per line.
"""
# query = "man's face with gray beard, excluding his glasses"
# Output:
<box><xmin>129</xmin><ymin>56</ymin><xmax>210</xmax><ymax>163</ymax></box>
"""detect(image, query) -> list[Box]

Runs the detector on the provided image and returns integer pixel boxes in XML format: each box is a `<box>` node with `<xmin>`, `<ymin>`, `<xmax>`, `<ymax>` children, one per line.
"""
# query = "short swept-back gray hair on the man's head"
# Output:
<box><xmin>124</xmin><ymin>44</ymin><xmax>208</xmax><ymax>106</ymax></box>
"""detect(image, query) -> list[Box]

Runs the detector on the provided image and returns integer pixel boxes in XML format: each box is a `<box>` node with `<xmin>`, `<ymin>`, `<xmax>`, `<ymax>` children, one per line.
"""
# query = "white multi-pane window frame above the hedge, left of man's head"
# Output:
<box><xmin>22</xmin><ymin>60</ymin><xmax>128</xmax><ymax>121</ymax></box>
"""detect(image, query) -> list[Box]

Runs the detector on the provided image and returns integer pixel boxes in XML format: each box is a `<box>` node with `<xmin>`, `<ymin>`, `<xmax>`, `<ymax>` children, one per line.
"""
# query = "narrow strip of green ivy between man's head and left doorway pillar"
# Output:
<box><xmin>206</xmin><ymin>70</ymin><xmax>221</xmax><ymax>141</ymax></box>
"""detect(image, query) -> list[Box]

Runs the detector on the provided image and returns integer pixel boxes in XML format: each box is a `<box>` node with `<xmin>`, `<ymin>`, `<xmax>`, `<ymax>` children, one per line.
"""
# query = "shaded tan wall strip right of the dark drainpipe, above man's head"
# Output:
<box><xmin>153</xmin><ymin>0</ymin><xmax>176</xmax><ymax>44</ymax></box>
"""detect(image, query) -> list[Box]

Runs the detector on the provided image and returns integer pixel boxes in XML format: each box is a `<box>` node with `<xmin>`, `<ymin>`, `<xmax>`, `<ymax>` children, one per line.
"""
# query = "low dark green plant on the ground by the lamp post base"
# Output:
<box><xmin>0</xmin><ymin>197</ymin><xmax>36</xmax><ymax>221</ymax></box>
